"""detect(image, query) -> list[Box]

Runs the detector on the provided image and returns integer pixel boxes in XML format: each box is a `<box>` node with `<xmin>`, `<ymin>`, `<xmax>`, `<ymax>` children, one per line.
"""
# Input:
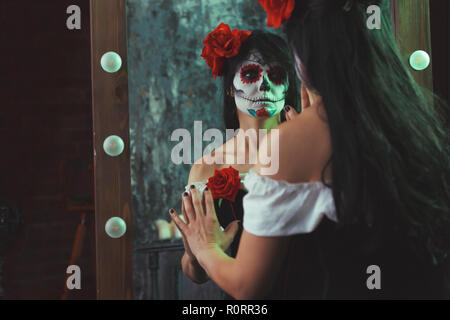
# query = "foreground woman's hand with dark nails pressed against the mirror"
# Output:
<box><xmin>169</xmin><ymin>188</ymin><xmax>238</xmax><ymax>259</ymax></box>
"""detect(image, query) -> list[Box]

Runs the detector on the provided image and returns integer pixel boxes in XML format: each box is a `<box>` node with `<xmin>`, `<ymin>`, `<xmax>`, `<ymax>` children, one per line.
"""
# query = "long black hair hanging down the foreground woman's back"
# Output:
<box><xmin>284</xmin><ymin>0</ymin><xmax>450</xmax><ymax>264</ymax></box>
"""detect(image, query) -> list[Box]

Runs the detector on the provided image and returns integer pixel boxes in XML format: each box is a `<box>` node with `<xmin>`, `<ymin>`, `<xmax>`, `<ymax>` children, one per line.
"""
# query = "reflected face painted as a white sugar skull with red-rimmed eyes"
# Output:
<box><xmin>233</xmin><ymin>52</ymin><xmax>289</xmax><ymax>117</ymax></box>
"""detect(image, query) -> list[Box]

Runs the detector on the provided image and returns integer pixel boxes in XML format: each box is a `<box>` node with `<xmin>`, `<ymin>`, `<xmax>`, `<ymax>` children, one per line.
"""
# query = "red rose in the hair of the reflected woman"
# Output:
<box><xmin>201</xmin><ymin>22</ymin><xmax>251</xmax><ymax>79</ymax></box>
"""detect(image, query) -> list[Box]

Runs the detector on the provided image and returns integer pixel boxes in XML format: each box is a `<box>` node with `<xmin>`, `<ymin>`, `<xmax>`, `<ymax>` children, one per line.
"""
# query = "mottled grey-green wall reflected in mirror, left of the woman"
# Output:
<box><xmin>127</xmin><ymin>0</ymin><xmax>284</xmax><ymax>299</ymax></box>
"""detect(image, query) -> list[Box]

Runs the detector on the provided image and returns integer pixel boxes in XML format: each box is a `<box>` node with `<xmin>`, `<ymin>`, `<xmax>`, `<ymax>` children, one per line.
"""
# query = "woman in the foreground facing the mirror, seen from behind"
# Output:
<box><xmin>171</xmin><ymin>0</ymin><xmax>450</xmax><ymax>299</ymax></box>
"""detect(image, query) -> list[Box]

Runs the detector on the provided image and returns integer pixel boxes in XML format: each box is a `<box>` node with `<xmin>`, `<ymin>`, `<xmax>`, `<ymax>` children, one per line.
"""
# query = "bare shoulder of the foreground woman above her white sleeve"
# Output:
<box><xmin>255</xmin><ymin>107</ymin><xmax>331</xmax><ymax>183</ymax></box>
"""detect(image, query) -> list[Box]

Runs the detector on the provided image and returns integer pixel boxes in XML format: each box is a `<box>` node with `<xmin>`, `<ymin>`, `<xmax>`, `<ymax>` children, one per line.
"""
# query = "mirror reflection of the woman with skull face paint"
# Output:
<box><xmin>182</xmin><ymin>24</ymin><xmax>300</xmax><ymax>292</ymax></box>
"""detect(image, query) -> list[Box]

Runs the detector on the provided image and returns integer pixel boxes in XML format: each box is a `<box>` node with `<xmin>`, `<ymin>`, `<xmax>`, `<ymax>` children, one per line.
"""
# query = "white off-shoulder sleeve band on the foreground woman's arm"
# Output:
<box><xmin>243</xmin><ymin>169</ymin><xmax>337</xmax><ymax>236</ymax></box>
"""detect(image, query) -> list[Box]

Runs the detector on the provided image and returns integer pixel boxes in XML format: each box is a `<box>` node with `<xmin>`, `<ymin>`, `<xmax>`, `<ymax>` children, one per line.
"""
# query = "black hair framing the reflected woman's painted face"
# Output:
<box><xmin>223</xmin><ymin>30</ymin><xmax>300</xmax><ymax>130</ymax></box>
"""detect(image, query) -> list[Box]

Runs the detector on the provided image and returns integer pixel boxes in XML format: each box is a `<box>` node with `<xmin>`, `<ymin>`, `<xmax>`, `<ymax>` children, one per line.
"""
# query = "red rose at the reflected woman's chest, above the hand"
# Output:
<box><xmin>206</xmin><ymin>166</ymin><xmax>241</xmax><ymax>202</ymax></box>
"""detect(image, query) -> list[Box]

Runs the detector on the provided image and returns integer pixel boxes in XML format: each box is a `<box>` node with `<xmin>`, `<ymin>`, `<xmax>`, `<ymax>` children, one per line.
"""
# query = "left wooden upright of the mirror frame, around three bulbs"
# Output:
<box><xmin>90</xmin><ymin>0</ymin><xmax>133</xmax><ymax>299</ymax></box>
